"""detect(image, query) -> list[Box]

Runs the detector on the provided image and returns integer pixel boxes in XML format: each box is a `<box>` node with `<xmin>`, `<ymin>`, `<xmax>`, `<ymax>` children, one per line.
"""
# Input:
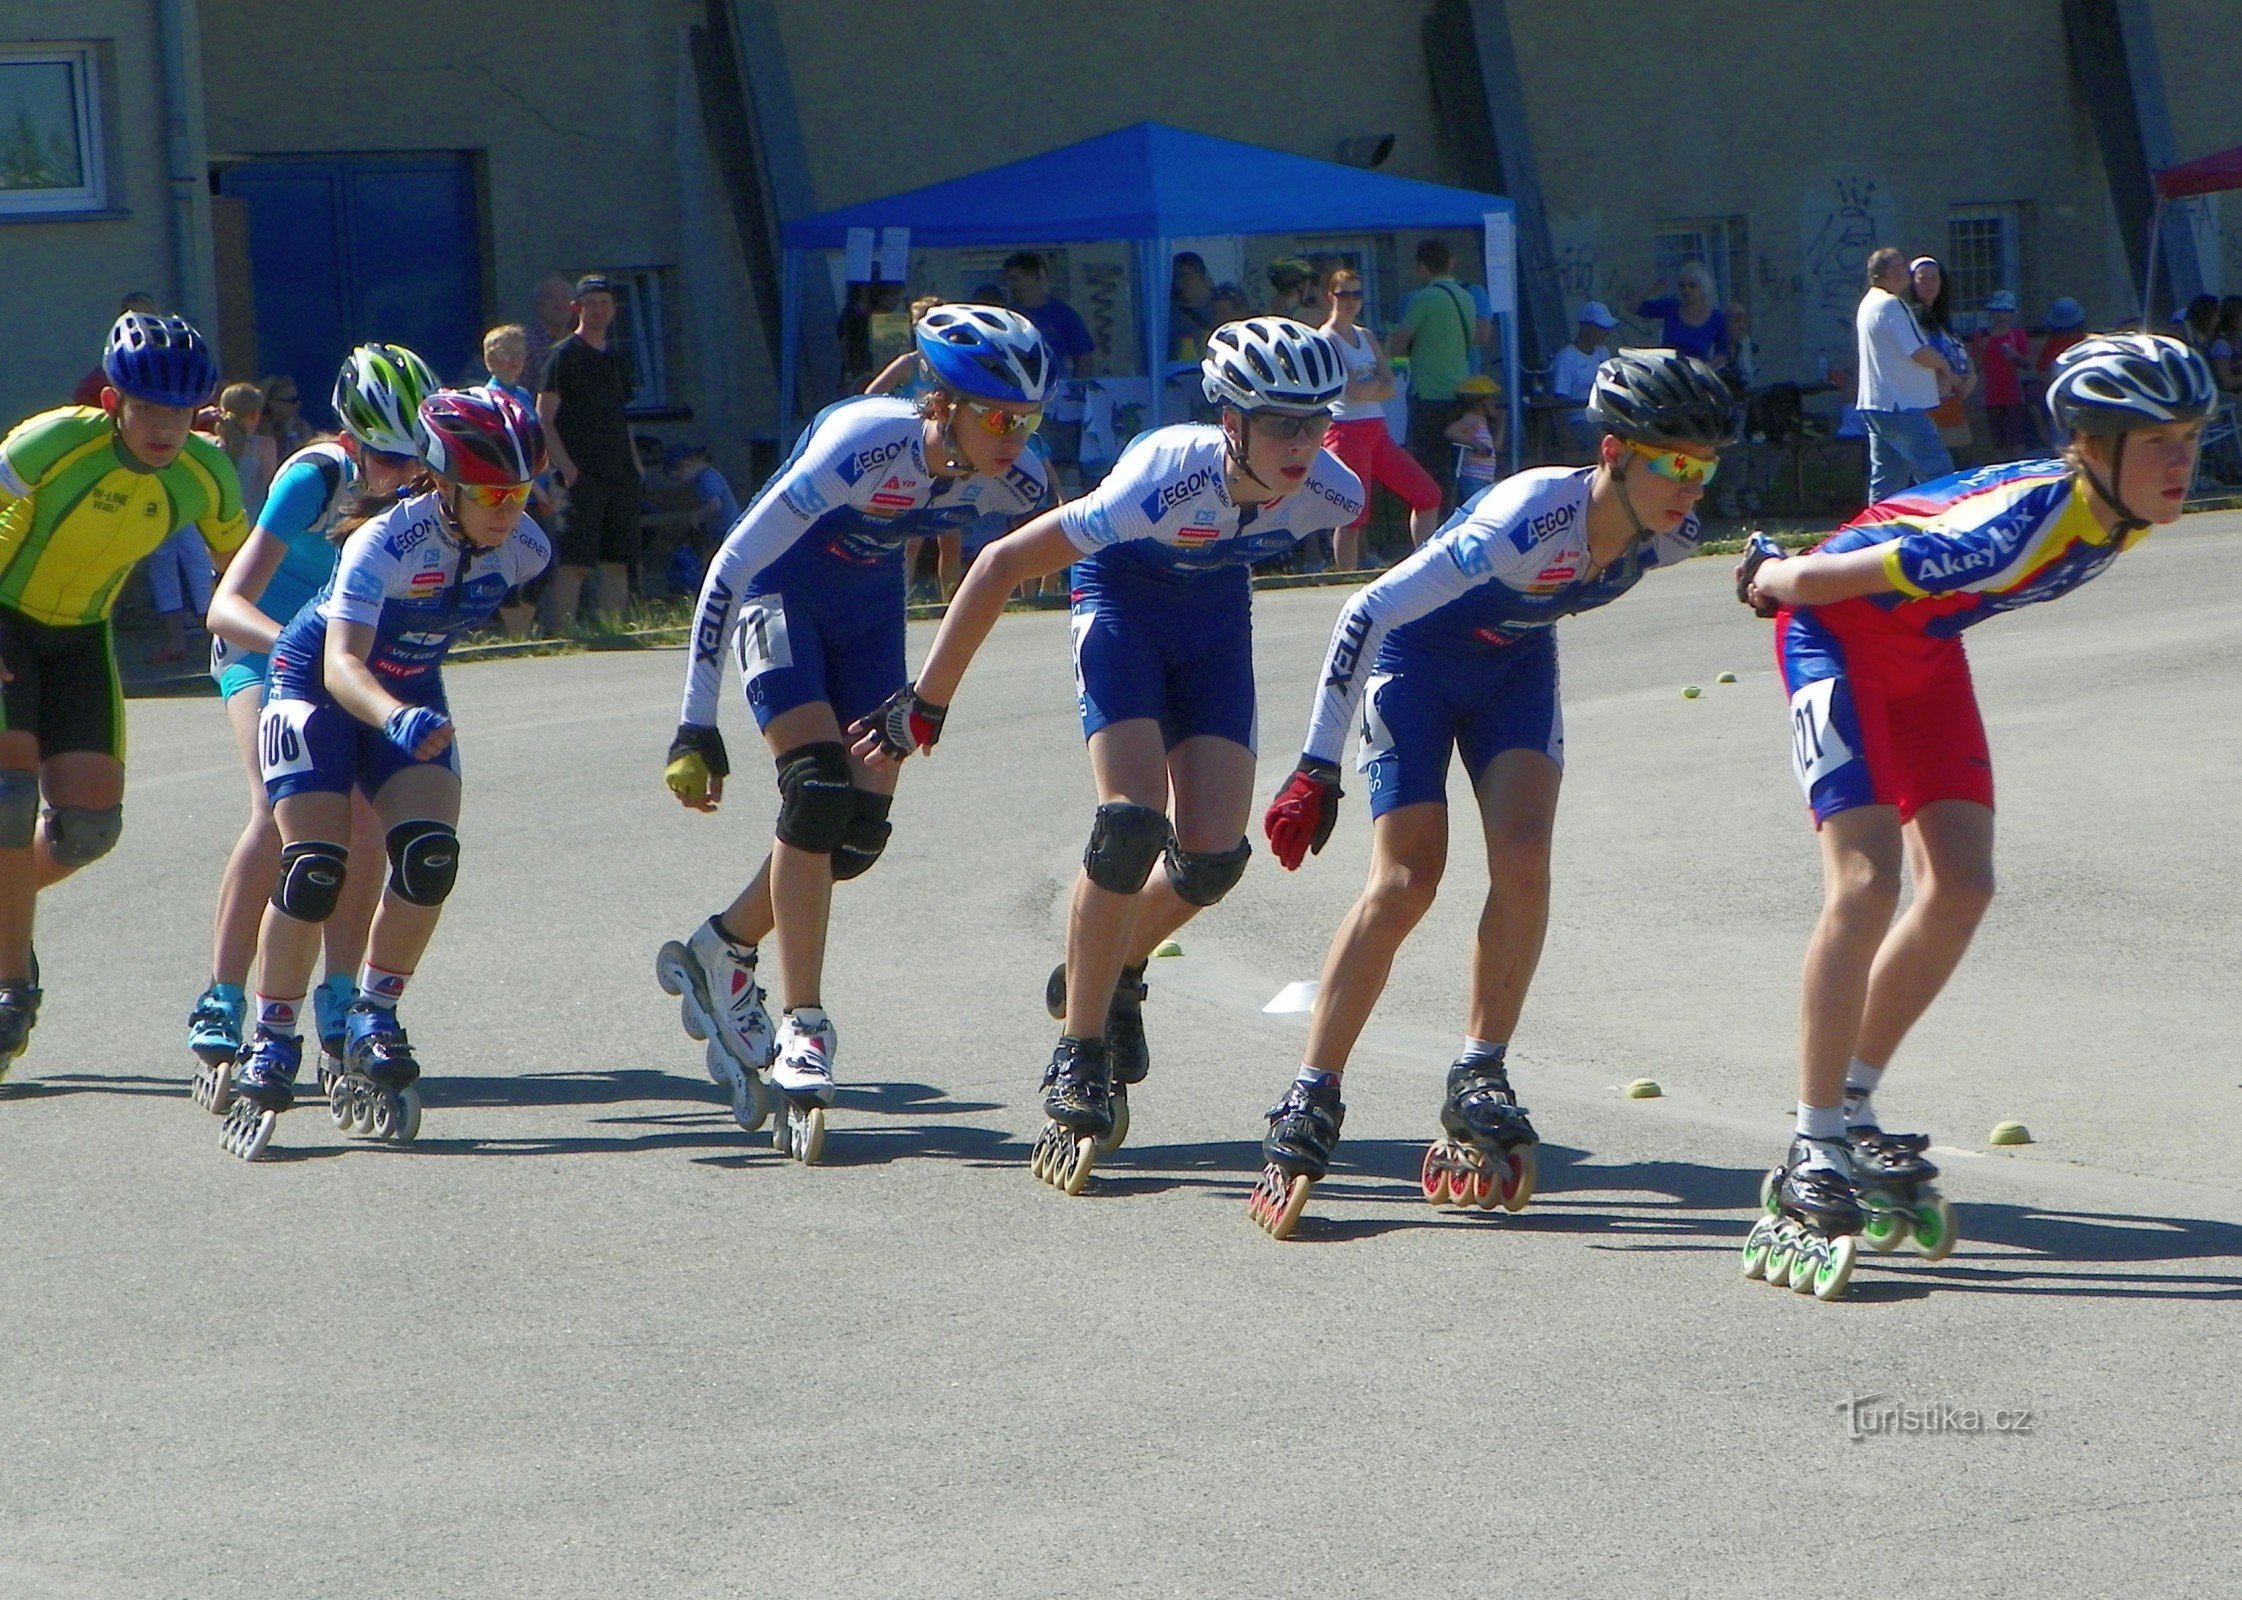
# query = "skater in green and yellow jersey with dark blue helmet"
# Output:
<box><xmin>0</xmin><ymin>311</ymin><xmax>249</xmax><ymax>1078</ymax></box>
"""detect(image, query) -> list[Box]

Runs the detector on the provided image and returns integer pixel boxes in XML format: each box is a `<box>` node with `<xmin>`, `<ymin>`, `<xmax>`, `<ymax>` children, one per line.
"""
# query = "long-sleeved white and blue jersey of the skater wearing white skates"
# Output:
<box><xmin>682</xmin><ymin>394</ymin><xmax>1051</xmax><ymax>726</ymax></box>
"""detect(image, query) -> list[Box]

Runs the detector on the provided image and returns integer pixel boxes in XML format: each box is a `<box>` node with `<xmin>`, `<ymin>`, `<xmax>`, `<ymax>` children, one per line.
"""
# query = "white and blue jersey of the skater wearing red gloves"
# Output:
<box><xmin>1300</xmin><ymin>466</ymin><xmax>1697</xmax><ymax>762</ymax></box>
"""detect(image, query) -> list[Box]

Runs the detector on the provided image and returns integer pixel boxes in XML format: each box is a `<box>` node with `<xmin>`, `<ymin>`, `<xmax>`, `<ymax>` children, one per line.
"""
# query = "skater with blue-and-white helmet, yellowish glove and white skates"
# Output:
<box><xmin>655</xmin><ymin>305</ymin><xmax>1051</xmax><ymax>1161</ymax></box>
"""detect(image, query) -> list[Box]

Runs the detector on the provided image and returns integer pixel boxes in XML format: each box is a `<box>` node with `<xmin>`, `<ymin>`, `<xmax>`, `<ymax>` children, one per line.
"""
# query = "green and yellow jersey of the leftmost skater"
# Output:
<box><xmin>0</xmin><ymin>406</ymin><xmax>249</xmax><ymax>627</ymax></box>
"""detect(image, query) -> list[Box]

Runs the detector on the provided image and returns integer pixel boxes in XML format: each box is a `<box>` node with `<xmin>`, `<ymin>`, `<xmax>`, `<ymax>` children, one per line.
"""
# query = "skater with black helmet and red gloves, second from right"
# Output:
<box><xmin>1249</xmin><ymin>350</ymin><xmax>1735</xmax><ymax>1239</ymax></box>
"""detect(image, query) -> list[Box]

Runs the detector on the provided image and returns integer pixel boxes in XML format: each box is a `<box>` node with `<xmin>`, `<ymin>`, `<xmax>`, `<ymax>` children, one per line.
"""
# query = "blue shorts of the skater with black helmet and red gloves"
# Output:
<box><xmin>1356</xmin><ymin>630</ymin><xmax>1565</xmax><ymax>816</ymax></box>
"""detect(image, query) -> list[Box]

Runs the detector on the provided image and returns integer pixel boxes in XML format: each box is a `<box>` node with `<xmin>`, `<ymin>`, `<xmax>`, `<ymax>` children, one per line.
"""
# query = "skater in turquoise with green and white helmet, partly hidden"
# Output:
<box><xmin>186</xmin><ymin>345</ymin><xmax>437</xmax><ymax>1111</ymax></box>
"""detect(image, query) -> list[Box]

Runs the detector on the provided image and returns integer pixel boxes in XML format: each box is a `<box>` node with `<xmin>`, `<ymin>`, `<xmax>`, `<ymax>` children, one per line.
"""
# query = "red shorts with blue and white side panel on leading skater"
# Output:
<box><xmin>1776</xmin><ymin>601</ymin><xmax>1993</xmax><ymax>822</ymax></box>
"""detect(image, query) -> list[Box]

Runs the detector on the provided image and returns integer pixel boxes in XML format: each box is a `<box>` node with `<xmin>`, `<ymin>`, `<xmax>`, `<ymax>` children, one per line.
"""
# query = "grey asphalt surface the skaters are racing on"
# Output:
<box><xmin>0</xmin><ymin>515</ymin><xmax>2242</xmax><ymax>1600</ymax></box>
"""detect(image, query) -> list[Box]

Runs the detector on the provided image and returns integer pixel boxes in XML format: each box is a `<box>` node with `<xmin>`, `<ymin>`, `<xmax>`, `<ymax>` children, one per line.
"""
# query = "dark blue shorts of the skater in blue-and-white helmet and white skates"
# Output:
<box><xmin>733</xmin><ymin>569</ymin><xmax>908</xmax><ymax>728</ymax></box>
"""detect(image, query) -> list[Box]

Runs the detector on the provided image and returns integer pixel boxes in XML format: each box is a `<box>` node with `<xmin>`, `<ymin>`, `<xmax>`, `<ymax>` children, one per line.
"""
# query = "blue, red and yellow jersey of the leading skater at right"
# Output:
<box><xmin>1814</xmin><ymin>462</ymin><xmax>2148</xmax><ymax>639</ymax></box>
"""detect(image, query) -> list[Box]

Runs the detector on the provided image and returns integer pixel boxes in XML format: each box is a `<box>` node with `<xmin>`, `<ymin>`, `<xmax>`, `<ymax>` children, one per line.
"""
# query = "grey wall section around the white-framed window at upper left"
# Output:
<box><xmin>0</xmin><ymin>0</ymin><xmax>190</xmax><ymax>430</ymax></box>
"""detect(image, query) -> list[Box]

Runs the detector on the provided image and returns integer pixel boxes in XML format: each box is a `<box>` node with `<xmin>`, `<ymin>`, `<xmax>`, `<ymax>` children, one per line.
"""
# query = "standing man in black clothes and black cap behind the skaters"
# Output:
<box><xmin>538</xmin><ymin>273</ymin><xmax>639</xmax><ymax>630</ymax></box>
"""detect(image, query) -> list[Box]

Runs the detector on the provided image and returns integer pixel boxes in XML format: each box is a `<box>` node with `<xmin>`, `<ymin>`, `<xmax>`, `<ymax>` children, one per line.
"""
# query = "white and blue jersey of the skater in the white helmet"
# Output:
<box><xmin>1058</xmin><ymin>421</ymin><xmax>1363</xmax><ymax>592</ymax></box>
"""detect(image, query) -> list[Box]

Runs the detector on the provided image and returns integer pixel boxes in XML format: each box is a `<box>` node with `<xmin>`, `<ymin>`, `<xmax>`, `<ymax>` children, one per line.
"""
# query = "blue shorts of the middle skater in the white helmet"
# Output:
<box><xmin>1072</xmin><ymin>567</ymin><xmax>1256</xmax><ymax>751</ymax></box>
